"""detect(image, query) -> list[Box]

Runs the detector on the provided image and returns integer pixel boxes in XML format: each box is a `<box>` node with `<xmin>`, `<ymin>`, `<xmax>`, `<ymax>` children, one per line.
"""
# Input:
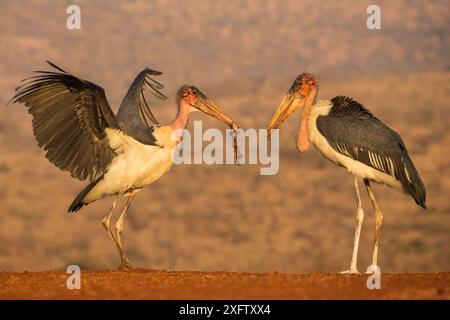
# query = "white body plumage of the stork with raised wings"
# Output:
<box><xmin>84</xmin><ymin>129</ymin><xmax>175</xmax><ymax>203</ymax></box>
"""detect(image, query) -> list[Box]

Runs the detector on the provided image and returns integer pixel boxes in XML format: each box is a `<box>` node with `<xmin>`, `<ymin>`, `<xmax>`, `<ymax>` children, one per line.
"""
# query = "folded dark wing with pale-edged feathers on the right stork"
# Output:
<box><xmin>317</xmin><ymin>96</ymin><xmax>426</xmax><ymax>207</ymax></box>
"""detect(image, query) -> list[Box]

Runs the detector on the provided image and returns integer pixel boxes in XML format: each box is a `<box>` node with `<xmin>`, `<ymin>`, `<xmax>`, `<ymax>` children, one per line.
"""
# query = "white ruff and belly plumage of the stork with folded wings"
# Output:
<box><xmin>308</xmin><ymin>100</ymin><xmax>403</xmax><ymax>190</ymax></box>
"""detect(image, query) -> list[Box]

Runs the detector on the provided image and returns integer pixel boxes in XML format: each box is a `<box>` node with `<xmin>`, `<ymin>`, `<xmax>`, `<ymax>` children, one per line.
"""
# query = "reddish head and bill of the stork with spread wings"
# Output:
<box><xmin>177</xmin><ymin>85</ymin><xmax>239</xmax><ymax>129</ymax></box>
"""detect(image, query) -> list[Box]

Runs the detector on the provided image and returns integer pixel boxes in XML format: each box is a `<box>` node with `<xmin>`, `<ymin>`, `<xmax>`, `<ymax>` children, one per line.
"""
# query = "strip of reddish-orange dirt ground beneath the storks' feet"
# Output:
<box><xmin>0</xmin><ymin>269</ymin><xmax>450</xmax><ymax>299</ymax></box>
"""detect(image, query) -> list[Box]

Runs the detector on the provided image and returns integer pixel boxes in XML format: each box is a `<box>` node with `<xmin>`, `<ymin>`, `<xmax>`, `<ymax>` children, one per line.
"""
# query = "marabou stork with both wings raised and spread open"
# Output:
<box><xmin>12</xmin><ymin>62</ymin><xmax>238</xmax><ymax>269</ymax></box>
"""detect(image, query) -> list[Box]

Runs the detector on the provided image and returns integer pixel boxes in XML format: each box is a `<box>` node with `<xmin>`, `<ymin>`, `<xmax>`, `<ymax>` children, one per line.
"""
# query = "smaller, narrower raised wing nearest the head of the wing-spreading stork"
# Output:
<box><xmin>117</xmin><ymin>68</ymin><xmax>167</xmax><ymax>145</ymax></box>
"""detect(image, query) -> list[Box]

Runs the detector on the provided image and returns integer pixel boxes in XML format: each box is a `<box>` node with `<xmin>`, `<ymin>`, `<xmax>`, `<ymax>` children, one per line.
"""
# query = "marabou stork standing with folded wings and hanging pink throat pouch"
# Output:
<box><xmin>268</xmin><ymin>73</ymin><xmax>426</xmax><ymax>273</ymax></box>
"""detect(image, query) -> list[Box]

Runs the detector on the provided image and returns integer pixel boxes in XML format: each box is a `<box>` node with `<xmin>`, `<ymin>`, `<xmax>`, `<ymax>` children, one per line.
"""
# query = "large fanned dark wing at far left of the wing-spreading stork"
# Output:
<box><xmin>12</xmin><ymin>62</ymin><xmax>118</xmax><ymax>181</ymax></box>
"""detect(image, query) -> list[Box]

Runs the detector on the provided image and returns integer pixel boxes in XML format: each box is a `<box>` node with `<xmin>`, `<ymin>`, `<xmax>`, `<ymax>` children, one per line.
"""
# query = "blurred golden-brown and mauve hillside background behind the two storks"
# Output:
<box><xmin>0</xmin><ymin>0</ymin><xmax>450</xmax><ymax>272</ymax></box>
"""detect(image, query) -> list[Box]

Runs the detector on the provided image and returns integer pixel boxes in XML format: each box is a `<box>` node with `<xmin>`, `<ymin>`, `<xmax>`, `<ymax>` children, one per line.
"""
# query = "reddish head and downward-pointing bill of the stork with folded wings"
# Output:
<box><xmin>267</xmin><ymin>72</ymin><xmax>317</xmax><ymax>135</ymax></box>
